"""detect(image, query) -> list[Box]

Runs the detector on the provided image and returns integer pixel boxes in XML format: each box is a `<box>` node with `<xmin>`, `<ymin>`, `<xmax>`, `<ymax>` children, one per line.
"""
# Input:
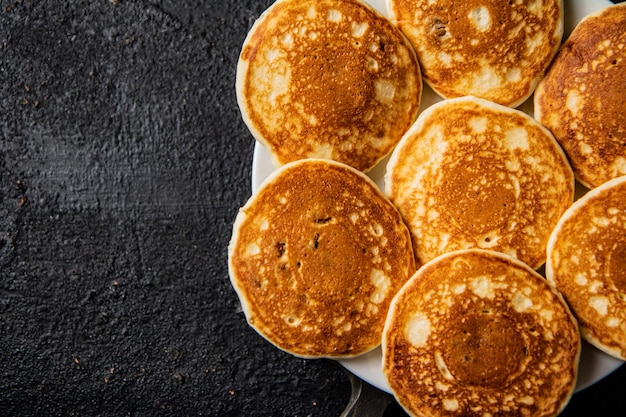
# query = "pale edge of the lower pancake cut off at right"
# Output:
<box><xmin>546</xmin><ymin>176</ymin><xmax>626</xmax><ymax>361</ymax></box>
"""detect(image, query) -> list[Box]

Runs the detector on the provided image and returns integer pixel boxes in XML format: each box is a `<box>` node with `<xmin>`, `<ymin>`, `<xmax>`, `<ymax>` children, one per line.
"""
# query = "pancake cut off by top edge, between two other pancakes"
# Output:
<box><xmin>387</xmin><ymin>0</ymin><xmax>563</xmax><ymax>107</ymax></box>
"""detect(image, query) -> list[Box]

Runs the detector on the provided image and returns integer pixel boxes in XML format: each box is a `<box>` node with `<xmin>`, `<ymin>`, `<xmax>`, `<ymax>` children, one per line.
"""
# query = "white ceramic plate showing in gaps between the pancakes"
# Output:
<box><xmin>252</xmin><ymin>0</ymin><xmax>623</xmax><ymax>392</ymax></box>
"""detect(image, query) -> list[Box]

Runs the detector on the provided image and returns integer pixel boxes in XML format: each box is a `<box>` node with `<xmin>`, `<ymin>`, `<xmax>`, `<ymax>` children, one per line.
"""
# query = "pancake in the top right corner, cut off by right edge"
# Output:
<box><xmin>534</xmin><ymin>4</ymin><xmax>626</xmax><ymax>188</ymax></box>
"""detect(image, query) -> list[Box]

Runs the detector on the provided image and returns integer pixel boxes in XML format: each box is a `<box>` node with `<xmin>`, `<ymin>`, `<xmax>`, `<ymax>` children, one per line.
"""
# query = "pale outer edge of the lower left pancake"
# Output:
<box><xmin>227</xmin><ymin>158</ymin><xmax>408</xmax><ymax>359</ymax></box>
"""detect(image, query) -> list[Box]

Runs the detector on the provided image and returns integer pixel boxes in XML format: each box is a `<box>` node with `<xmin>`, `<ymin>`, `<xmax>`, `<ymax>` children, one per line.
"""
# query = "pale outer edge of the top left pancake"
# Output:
<box><xmin>235</xmin><ymin>0</ymin><xmax>424</xmax><ymax>168</ymax></box>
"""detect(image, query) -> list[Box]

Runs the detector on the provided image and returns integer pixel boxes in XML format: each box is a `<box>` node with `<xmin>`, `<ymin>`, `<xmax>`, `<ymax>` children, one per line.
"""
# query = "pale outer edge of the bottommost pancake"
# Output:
<box><xmin>381</xmin><ymin>249</ymin><xmax>582</xmax><ymax>415</ymax></box>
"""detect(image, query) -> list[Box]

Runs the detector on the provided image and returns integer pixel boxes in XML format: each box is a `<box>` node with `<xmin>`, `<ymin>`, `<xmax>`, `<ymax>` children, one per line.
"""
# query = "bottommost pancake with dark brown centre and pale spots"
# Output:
<box><xmin>382</xmin><ymin>249</ymin><xmax>581</xmax><ymax>417</ymax></box>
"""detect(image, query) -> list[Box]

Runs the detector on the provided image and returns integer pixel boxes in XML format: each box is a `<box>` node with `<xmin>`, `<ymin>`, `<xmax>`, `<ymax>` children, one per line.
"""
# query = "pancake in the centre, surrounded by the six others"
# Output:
<box><xmin>385</xmin><ymin>97</ymin><xmax>574</xmax><ymax>269</ymax></box>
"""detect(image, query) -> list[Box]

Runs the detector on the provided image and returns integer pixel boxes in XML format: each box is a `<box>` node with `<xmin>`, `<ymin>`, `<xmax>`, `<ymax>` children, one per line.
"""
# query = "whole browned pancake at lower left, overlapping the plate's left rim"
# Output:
<box><xmin>229</xmin><ymin>159</ymin><xmax>415</xmax><ymax>358</ymax></box>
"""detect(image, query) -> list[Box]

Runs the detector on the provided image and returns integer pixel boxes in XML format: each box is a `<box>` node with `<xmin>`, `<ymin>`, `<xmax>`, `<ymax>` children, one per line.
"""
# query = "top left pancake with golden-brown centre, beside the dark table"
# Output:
<box><xmin>236</xmin><ymin>0</ymin><xmax>422</xmax><ymax>171</ymax></box>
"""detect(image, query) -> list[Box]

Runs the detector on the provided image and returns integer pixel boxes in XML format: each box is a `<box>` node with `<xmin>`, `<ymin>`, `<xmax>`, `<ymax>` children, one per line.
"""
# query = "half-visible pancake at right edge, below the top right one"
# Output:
<box><xmin>546</xmin><ymin>177</ymin><xmax>626</xmax><ymax>360</ymax></box>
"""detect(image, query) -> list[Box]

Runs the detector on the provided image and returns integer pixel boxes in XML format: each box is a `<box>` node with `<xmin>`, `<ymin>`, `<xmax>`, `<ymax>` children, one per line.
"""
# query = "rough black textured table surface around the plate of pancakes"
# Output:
<box><xmin>0</xmin><ymin>0</ymin><xmax>626</xmax><ymax>416</ymax></box>
